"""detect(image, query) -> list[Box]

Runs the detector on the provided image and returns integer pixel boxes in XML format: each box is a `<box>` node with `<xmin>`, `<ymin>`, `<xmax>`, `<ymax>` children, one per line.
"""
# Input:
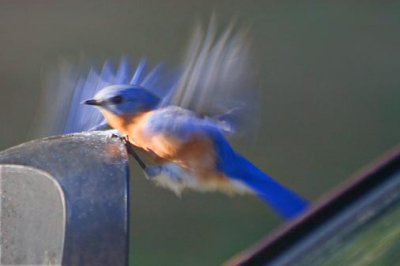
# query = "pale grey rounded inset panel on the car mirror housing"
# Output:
<box><xmin>0</xmin><ymin>165</ymin><xmax>65</xmax><ymax>265</ymax></box>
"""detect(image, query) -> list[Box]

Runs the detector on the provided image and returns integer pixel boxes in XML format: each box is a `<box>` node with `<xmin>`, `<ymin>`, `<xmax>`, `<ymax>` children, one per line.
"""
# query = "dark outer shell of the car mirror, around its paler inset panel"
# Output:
<box><xmin>0</xmin><ymin>132</ymin><xmax>129</xmax><ymax>266</ymax></box>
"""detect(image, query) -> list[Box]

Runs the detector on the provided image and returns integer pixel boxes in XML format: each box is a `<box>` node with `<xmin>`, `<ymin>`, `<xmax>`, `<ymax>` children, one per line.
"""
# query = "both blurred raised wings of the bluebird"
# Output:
<box><xmin>37</xmin><ymin>19</ymin><xmax>257</xmax><ymax>136</ymax></box>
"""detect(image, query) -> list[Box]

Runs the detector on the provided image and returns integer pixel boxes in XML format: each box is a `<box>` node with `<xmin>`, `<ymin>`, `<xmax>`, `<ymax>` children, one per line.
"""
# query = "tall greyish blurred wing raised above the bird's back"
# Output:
<box><xmin>162</xmin><ymin>20</ymin><xmax>256</xmax><ymax>135</ymax></box>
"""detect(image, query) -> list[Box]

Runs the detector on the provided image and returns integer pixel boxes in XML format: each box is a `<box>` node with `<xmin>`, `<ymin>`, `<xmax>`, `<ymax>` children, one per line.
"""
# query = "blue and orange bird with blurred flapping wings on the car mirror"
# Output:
<box><xmin>40</xmin><ymin>23</ymin><xmax>308</xmax><ymax>219</ymax></box>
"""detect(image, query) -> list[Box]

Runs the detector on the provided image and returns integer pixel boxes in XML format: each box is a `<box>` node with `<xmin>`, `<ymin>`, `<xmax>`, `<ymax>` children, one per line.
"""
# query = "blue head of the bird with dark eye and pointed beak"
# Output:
<box><xmin>83</xmin><ymin>85</ymin><xmax>160</xmax><ymax>115</ymax></box>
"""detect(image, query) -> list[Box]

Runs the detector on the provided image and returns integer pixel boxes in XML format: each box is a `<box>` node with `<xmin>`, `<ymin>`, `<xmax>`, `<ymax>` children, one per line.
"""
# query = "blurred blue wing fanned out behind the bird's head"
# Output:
<box><xmin>36</xmin><ymin>58</ymin><xmax>172</xmax><ymax>136</ymax></box>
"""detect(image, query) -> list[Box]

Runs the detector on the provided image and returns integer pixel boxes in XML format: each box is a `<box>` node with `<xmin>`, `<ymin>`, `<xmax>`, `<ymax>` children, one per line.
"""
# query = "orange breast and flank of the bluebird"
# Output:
<box><xmin>103</xmin><ymin>111</ymin><xmax>229</xmax><ymax>188</ymax></box>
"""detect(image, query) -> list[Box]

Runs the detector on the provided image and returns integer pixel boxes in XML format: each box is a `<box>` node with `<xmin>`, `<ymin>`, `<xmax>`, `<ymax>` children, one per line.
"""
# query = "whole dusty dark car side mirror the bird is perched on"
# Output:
<box><xmin>0</xmin><ymin>132</ymin><xmax>129</xmax><ymax>266</ymax></box>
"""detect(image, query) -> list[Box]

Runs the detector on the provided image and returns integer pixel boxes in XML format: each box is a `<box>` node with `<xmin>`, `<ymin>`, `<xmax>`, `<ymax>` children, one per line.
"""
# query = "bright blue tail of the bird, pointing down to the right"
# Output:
<box><xmin>215</xmin><ymin>134</ymin><xmax>308</xmax><ymax>220</ymax></box>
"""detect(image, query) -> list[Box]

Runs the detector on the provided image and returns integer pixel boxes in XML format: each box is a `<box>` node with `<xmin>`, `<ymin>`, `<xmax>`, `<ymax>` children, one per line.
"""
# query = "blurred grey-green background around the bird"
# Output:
<box><xmin>0</xmin><ymin>0</ymin><xmax>400</xmax><ymax>265</ymax></box>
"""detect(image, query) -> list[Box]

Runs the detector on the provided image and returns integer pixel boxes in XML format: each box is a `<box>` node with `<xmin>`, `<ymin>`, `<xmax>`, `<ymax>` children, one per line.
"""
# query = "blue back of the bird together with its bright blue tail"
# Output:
<box><xmin>145</xmin><ymin>106</ymin><xmax>308</xmax><ymax>219</ymax></box>
